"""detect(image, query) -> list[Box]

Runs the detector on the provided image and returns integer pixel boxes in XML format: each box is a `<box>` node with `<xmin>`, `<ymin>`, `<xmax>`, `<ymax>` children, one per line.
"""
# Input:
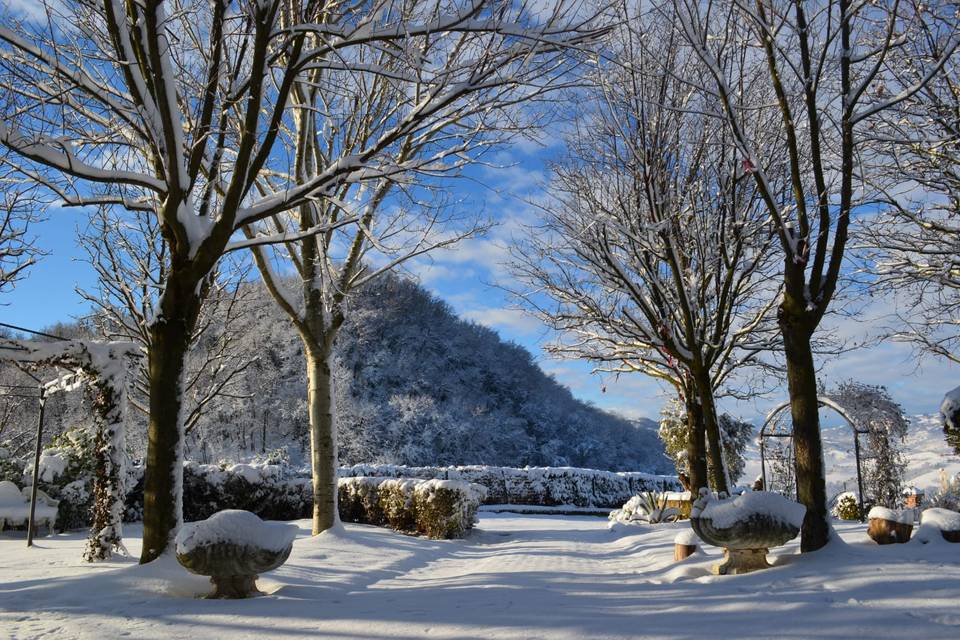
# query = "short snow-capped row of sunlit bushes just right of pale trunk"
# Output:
<box><xmin>338</xmin><ymin>476</ymin><xmax>487</xmax><ymax>539</ymax></box>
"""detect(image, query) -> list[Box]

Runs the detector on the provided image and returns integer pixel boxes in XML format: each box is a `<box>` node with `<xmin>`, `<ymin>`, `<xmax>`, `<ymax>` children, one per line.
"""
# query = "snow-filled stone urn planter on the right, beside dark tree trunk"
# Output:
<box><xmin>690</xmin><ymin>489</ymin><xmax>806</xmax><ymax>575</ymax></box>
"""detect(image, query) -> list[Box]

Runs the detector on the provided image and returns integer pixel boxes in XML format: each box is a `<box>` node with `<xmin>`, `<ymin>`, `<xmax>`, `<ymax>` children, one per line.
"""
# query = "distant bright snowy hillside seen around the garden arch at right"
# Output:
<box><xmin>740</xmin><ymin>412</ymin><xmax>960</xmax><ymax>497</ymax></box>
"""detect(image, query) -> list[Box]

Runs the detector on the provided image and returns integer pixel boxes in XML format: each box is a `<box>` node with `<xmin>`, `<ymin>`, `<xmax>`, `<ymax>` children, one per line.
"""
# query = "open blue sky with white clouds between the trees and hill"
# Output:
<box><xmin>0</xmin><ymin>139</ymin><xmax>960</xmax><ymax>421</ymax></box>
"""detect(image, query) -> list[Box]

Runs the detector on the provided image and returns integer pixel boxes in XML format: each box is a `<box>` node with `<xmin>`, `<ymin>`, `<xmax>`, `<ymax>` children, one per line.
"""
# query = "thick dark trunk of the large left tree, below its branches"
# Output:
<box><xmin>140</xmin><ymin>277</ymin><xmax>202</xmax><ymax>564</ymax></box>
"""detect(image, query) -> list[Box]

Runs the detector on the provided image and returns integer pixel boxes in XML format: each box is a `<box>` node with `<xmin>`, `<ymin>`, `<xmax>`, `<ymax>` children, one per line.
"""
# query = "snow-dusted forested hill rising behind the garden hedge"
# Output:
<box><xmin>5</xmin><ymin>276</ymin><xmax>671</xmax><ymax>472</ymax></box>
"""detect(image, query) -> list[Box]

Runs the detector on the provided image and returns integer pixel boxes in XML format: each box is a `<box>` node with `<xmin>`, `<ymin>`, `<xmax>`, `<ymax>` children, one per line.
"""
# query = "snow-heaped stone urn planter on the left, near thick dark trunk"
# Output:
<box><xmin>176</xmin><ymin>509</ymin><xmax>297</xmax><ymax>598</ymax></box>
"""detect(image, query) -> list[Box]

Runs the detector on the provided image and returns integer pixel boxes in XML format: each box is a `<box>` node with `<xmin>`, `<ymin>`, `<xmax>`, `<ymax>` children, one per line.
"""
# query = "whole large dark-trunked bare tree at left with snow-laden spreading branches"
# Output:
<box><xmin>0</xmin><ymin>0</ymin><xmax>593</xmax><ymax>562</ymax></box>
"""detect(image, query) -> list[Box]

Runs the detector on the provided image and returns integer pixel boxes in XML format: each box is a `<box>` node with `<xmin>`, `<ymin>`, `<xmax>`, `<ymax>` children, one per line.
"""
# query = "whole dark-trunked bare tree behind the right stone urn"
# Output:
<box><xmin>676</xmin><ymin>0</ymin><xmax>958</xmax><ymax>551</ymax></box>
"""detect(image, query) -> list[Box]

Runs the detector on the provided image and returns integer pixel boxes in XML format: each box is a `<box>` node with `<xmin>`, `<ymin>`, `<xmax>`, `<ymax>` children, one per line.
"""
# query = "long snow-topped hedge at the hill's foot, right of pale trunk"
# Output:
<box><xmin>340</xmin><ymin>464</ymin><xmax>681</xmax><ymax>509</ymax></box>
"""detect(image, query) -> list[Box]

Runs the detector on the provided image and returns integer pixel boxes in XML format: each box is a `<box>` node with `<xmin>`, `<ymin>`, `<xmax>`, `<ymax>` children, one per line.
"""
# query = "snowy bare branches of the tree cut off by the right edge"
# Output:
<box><xmin>856</xmin><ymin>28</ymin><xmax>960</xmax><ymax>364</ymax></box>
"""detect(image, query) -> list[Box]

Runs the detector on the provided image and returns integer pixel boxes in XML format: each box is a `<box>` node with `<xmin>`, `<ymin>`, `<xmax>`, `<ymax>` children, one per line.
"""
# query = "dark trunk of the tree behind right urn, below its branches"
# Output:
<box><xmin>780</xmin><ymin>307</ymin><xmax>829</xmax><ymax>552</ymax></box>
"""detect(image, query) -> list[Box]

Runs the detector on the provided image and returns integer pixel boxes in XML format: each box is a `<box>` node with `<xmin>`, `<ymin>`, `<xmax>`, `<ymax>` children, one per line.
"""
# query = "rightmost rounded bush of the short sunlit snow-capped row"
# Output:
<box><xmin>413</xmin><ymin>480</ymin><xmax>486</xmax><ymax>539</ymax></box>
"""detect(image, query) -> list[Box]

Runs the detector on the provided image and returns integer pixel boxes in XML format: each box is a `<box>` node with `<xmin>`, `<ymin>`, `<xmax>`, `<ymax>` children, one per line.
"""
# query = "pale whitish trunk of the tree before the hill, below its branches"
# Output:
<box><xmin>304</xmin><ymin>341</ymin><xmax>340</xmax><ymax>535</ymax></box>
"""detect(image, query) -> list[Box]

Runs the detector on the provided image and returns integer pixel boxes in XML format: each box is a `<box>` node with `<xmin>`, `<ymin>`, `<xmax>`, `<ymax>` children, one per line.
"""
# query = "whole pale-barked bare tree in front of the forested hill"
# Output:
<box><xmin>245</xmin><ymin>1</ymin><xmax>604</xmax><ymax>534</ymax></box>
